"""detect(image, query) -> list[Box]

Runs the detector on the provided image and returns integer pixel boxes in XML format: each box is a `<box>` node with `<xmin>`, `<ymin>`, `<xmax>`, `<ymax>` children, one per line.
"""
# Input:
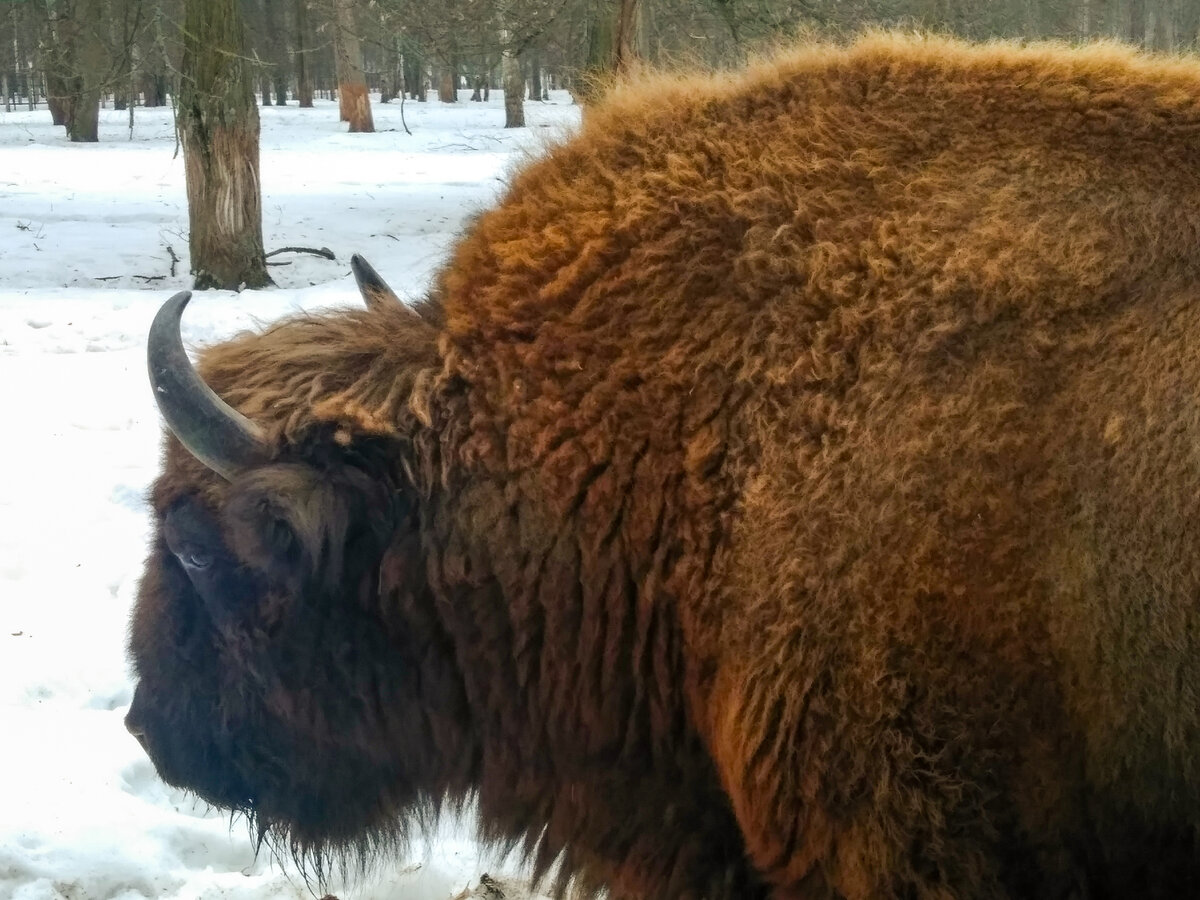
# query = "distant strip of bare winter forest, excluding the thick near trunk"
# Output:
<box><xmin>0</xmin><ymin>0</ymin><xmax>1200</xmax><ymax>133</ymax></box>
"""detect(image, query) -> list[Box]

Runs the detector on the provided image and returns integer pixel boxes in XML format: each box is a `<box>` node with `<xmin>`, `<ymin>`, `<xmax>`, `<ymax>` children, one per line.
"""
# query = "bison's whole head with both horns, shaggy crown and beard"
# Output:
<box><xmin>126</xmin><ymin>258</ymin><xmax>470</xmax><ymax>866</ymax></box>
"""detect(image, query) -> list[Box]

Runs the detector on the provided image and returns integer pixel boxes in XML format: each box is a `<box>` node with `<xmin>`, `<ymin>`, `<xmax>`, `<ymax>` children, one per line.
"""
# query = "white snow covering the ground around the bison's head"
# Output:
<box><xmin>0</xmin><ymin>92</ymin><xmax>578</xmax><ymax>900</ymax></box>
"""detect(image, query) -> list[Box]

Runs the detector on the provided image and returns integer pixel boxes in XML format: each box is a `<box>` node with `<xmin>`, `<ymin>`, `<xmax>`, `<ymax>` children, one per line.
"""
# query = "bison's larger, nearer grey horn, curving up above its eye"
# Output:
<box><xmin>146</xmin><ymin>290</ymin><xmax>268</xmax><ymax>480</ymax></box>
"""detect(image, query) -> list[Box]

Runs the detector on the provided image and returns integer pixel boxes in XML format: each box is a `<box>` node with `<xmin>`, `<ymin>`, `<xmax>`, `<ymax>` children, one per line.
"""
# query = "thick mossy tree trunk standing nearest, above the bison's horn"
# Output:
<box><xmin>179</xmin><ymin>0</ymin><xmax>271</xmax><ymax>290</ymax></box>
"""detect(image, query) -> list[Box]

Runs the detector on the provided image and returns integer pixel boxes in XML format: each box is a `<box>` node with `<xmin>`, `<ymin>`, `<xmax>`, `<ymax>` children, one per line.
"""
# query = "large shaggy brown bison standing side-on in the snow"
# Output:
<box><xmin>127</xmin><ymin>35</ymin><xmax>1200</xmax><ymax>900</ymax></box>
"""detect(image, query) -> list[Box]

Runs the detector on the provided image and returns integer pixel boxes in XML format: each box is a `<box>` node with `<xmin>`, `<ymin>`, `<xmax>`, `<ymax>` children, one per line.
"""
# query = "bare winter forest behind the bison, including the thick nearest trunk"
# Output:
<box><xmin>7</xmin><ymin>0</ymin><xmax>1200</xmax><ymax>288</ymax></box>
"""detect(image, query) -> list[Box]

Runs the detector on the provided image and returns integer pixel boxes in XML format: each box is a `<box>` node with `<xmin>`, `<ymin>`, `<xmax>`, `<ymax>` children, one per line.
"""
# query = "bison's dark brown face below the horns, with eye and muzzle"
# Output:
<box><xmin>126</xmin><ymin>451</ymin><xmax>432</xmax><ymax>846</ymax></box>
